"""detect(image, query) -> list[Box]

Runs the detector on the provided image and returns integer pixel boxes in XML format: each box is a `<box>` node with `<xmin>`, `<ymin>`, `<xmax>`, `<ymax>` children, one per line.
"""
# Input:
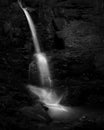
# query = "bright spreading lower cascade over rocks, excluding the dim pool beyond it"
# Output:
<box><xmin>27</xmin><ymin>85</ymin><xmax>69</xmax><ymax>116</ymax></box>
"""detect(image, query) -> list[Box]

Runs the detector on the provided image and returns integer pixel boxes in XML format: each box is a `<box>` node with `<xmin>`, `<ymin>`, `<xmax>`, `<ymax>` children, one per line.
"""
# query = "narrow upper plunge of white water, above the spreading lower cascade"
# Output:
<box><xmin>18</xmin><ymin>1</ymin><xmax>51</xmax><ymax>87</ymax></box>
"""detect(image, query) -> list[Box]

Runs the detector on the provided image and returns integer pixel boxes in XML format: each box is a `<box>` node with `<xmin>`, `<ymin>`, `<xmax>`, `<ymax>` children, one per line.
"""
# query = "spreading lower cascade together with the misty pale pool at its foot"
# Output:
<box><xmin>27</xmin><ymin>85</ymin><xmax>83</xmax><ymax>121</ymax></box>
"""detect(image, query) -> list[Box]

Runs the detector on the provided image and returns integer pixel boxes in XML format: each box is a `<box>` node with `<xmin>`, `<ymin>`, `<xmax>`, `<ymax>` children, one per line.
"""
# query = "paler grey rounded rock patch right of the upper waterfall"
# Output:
<box><xmin>62</xmin><ymin>21</ymin><xmax>101</xmax><ymax>51</ymax></box>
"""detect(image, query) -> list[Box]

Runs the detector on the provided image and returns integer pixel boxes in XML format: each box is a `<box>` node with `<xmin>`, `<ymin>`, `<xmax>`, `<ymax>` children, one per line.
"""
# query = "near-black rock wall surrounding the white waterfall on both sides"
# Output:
<box><xmin>0</xmin><ymin>0</ymin><xmax>104</xmax><ymax>130</ymax></box>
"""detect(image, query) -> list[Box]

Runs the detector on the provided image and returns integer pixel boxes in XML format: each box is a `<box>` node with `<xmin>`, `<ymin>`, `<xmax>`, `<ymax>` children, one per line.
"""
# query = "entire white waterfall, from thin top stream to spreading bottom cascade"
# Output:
<box><xmin>18</xmin><ymin>1</ymin><xmax>69</xmax><ymax>116</ymax></box>
